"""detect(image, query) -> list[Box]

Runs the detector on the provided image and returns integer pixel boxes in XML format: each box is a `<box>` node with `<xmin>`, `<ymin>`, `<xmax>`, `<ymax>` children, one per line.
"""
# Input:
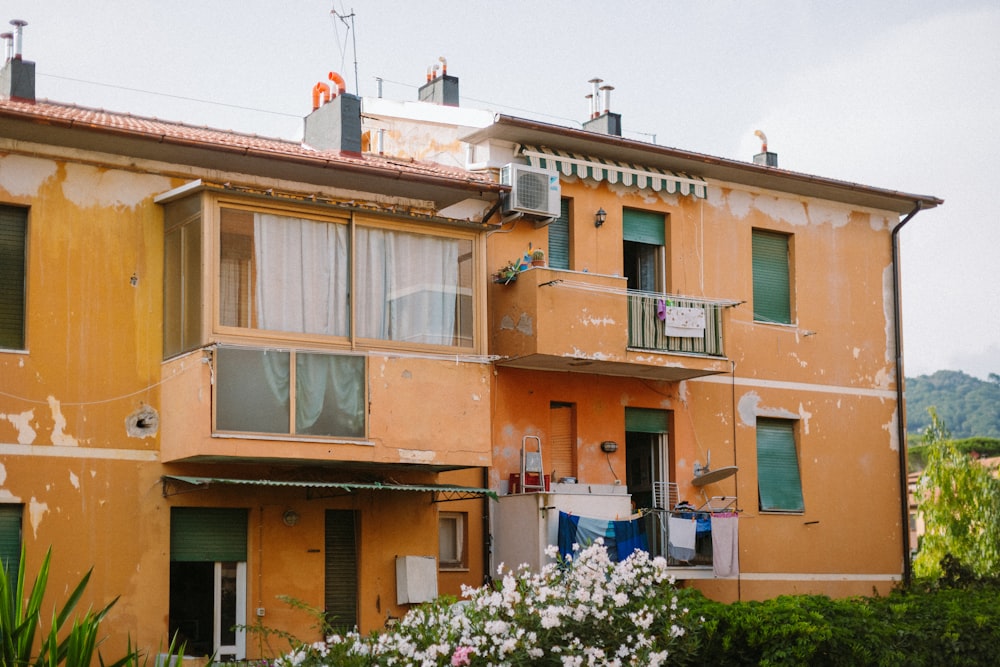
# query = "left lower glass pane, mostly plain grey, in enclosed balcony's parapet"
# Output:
<box><xmin>215</xmin><ymin>347</ymin><xmax>290</xmax><ymax>433</ymax></box>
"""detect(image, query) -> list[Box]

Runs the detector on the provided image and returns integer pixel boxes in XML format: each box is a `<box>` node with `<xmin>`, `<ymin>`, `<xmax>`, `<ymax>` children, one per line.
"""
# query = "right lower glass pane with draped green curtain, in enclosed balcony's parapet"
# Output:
<box><xmin>295</xmin><ymin>352</ymin><xmax>365</xmax><ymax>438</ymax></box>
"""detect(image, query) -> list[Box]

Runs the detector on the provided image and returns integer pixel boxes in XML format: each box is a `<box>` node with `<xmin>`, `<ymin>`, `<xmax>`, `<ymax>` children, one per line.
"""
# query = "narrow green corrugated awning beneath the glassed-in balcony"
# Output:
<box><xmin>160</xmin><ymin>475</ymin><xmax>497</xmax><ymax>503</ymax></box>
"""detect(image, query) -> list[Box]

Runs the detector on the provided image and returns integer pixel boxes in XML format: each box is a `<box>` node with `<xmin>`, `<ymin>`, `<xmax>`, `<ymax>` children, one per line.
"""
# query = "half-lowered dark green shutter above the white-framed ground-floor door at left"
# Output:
<box><xmin>170</xmin><ymin>507</ymin><xmax>247</xmax><ymax>563</ymax></box>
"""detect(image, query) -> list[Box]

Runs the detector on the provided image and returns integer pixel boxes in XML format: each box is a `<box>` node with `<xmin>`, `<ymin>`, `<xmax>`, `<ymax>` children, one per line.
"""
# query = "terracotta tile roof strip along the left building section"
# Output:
<box><xmin>0</xmin><ymin>98</ymin><xmax>498</xmax><ymax>189</ymax></box>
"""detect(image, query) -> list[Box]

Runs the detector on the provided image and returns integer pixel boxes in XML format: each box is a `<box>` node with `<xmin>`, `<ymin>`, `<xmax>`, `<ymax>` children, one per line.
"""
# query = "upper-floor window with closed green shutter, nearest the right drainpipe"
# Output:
<box><xmin>750</xmin><ymin>228</ymin><xmax>795</xmax><ymax>326</ymax></box>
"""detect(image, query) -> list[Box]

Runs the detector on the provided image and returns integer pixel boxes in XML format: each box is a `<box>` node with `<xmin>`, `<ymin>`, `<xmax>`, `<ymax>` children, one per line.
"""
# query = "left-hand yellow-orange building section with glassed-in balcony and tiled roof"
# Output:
<box><xmin>0</xmin><ymin>43</ymin><xmax>502</xmax><ymax>659</ymax></box>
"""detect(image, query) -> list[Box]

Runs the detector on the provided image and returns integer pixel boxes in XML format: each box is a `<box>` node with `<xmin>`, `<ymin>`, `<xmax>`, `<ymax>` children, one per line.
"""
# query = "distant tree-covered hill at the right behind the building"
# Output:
<box><xmin>906</xmin><ymin>371</ymin><xmax>1000</xmax><ymax>440</ymax></box>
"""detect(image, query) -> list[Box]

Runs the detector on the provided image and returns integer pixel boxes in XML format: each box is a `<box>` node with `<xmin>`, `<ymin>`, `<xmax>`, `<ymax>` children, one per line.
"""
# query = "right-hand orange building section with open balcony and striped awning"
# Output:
<box><xmin>364</xmin><ymin>70</ymin><xmax>942</xmax><ymax>600</ymax></box>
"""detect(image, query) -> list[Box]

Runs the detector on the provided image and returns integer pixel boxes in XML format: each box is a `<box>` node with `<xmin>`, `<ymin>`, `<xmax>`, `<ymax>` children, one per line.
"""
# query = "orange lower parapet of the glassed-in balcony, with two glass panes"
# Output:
<box><xmin>160</xmin><ymin>344</ymin><xmax>492</xmax><ymax>472</ymax></box>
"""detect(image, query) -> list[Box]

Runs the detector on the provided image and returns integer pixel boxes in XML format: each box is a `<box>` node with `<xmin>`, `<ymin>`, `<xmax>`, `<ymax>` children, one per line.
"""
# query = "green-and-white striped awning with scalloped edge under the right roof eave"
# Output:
<box><xmin>521</xmin><ymin>146</ymin><xmax>708</xmax><ymax>199</ymax></box>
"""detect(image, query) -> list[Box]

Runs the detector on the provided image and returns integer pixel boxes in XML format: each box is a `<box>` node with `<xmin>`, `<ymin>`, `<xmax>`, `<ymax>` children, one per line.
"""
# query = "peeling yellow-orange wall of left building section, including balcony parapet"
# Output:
<box><xmin>0</xmin><ymin>147</ymin><xmax>492</xmax><ymax>658</ymax></box>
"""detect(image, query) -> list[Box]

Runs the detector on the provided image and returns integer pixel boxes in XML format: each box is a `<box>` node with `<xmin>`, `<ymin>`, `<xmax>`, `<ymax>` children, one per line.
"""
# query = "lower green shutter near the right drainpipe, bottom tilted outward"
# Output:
<box><xmin>757</xmin><ymin>419</ymin><xmax>805</xmax><ymax>512</ymax></box>
